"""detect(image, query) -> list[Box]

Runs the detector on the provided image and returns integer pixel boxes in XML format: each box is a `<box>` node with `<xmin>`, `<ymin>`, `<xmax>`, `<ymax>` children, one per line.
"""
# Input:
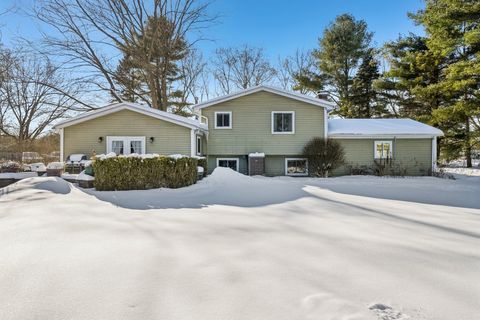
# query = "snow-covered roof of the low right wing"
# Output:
<box><xmin>328</xmin><ymin>119</ymin><xmax>443</xmax><ymax>138</ymax></box>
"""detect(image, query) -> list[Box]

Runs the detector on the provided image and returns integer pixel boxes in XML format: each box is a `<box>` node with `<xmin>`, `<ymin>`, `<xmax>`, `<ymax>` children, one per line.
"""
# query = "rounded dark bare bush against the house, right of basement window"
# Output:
<box><xmin>303</xmin><ymin>138</ymin><xmax>345</xmax><ymax>177</ymax></box>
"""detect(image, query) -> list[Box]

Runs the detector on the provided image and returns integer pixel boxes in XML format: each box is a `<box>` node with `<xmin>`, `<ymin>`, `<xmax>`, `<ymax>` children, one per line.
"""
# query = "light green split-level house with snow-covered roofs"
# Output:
<box><xmin>55</xmin><ymin>86</ymin><xmax>443</xmax><ymax>176</ymax></box>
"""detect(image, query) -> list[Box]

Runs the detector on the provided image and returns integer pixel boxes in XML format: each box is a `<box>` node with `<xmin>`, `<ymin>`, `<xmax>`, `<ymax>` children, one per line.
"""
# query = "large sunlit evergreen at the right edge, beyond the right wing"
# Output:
<box><xmin>412</xmin><ymin>0</ymin><xmax>480</xmax><ymax>167</ymax></box>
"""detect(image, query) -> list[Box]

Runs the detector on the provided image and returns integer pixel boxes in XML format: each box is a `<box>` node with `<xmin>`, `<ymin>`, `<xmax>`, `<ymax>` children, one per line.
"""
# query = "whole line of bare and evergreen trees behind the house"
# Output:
<box><xmin>0</xmin><ymin>0</ymin><xmax>480</xmax><ymax>165</ymax></box>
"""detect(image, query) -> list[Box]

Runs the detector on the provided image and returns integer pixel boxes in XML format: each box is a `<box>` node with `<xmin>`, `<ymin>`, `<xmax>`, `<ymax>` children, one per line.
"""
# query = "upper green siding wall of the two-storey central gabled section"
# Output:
<box><xmin>201</xmin><ymin>91</ymin><xmax>324</xmax><ymax>155</ymax></box>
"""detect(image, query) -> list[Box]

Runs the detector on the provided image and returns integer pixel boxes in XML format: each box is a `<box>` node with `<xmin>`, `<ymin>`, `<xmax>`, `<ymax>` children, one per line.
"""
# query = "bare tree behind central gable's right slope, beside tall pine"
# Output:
<box><xmin>276</xmin><ymin>49</ymin><xmax>315</xmax><ymax>94</ymax></box>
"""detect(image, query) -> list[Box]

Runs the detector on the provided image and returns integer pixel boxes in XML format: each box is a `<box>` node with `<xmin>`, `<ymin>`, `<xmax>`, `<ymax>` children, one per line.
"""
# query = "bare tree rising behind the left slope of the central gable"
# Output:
<box><xmin>213</xmin><ymin>45</ymin><xmax>276</xmax><ymax>94</ymax></box>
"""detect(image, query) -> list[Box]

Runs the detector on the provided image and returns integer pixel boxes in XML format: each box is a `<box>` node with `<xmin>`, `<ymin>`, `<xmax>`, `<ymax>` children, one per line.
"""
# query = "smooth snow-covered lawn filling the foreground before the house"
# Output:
<box><xmin>0</xmin><ymin>169</ymin><xmax>480</xmax><ymax>320</ymax></box>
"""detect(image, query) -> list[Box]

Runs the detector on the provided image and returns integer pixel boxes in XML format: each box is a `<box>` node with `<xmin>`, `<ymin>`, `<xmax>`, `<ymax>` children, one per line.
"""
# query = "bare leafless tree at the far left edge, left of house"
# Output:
<box><xmin>0</xmin><ymin>50</ymin><xmax>79</xmax><ymax>145</ymax></box>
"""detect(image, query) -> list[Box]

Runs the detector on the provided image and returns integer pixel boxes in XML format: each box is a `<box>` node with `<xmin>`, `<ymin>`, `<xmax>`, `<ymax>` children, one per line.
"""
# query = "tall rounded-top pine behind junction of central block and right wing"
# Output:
<box><xmin>296</xmin><ymin>14</ymin><xmax>373</xmax><ymax>116</ymax></box>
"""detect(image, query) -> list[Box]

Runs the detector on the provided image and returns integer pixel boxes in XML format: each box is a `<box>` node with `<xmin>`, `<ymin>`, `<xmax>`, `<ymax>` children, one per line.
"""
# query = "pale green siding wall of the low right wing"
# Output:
<box><xmin>333</xmin><ymin>138</ymin><xmax>432</xmax><ymax>175</ymax></box>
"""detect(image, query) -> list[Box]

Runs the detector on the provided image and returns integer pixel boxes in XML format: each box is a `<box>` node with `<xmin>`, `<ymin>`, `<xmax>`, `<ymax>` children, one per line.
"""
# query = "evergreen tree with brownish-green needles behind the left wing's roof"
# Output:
<box><xmin>115</xmin><ymin>16</ymin><xmax>188</xmax><ymax>113</ymax></box>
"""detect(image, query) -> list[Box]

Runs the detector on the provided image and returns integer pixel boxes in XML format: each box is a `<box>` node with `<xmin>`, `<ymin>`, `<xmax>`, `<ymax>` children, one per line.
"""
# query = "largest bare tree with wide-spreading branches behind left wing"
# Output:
<box><xmin>35</xmin><ymin>0</ymin><xmax>217</xmax><ymax>110</ymax></box>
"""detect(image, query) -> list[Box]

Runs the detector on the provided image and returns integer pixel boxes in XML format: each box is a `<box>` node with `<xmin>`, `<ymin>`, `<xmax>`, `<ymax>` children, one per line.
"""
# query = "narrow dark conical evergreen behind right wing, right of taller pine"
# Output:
<box><xmin>349</xmin><ymin>49</ymin><xmax>385</xmax><ymax>118</ymax></box>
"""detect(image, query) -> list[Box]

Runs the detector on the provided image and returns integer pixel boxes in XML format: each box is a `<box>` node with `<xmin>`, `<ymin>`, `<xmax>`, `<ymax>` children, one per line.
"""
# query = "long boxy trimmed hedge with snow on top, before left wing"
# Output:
<box><xmin>93</xmin><ymin>156</ymin><xmax>198</xmax><ymax>191</ymax></box>
